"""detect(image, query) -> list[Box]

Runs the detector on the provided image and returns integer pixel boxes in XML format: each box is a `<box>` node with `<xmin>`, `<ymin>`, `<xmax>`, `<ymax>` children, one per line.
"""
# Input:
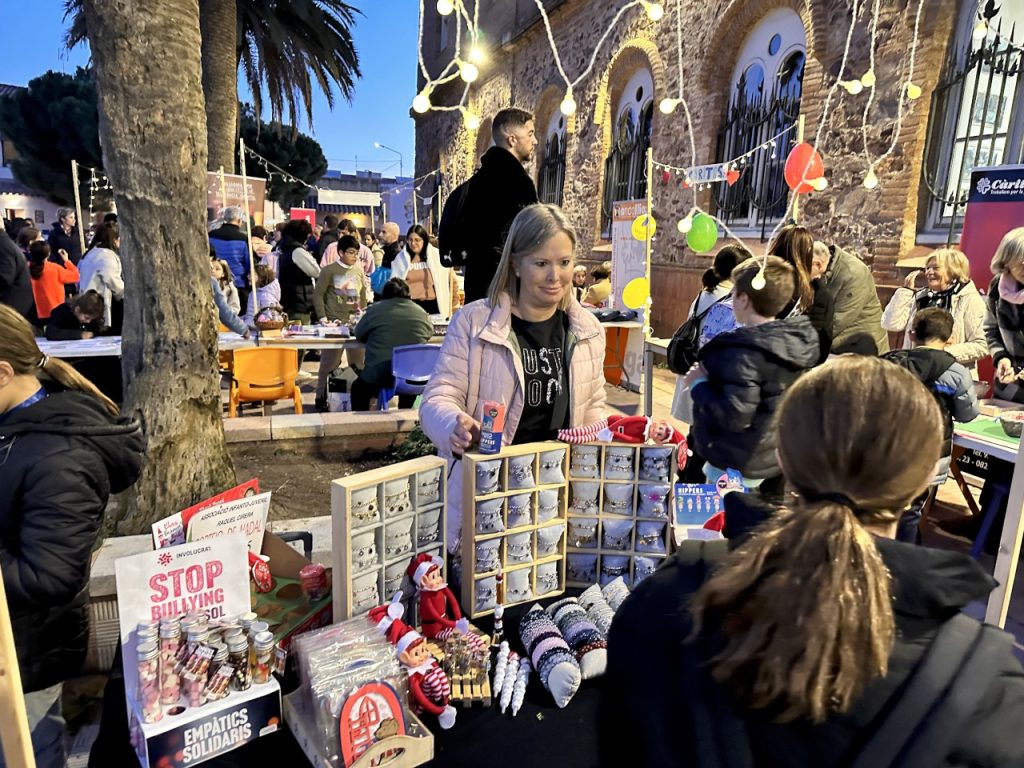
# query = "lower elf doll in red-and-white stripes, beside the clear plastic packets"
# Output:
<box><xmin>370</xmin><ymin>593</ymin><xmax>456</xmax><ymax>730</ymax></box>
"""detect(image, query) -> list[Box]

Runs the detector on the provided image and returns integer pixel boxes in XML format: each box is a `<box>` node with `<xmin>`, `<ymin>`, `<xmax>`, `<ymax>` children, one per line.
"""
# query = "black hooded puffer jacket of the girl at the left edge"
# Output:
<box><xmin>0</xmin><ymin>391</ymin><xmax>145</xmax><ymax>692</ymax></box>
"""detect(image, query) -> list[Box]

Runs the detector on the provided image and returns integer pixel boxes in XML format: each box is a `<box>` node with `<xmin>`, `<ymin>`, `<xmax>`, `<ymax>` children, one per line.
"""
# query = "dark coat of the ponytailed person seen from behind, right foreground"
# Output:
<box><xmin>601</xmin><ymin>494</ymin><xmax>1024</xmax><ymax>768</ymax></box>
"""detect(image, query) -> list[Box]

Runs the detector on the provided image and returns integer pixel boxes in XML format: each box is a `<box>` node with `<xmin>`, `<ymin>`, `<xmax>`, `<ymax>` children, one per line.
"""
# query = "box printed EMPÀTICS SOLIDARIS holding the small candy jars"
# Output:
<box><xmin>129</xmin><ymin>677</ymin><xmax>281</xmax><ymax>768</ymax></box>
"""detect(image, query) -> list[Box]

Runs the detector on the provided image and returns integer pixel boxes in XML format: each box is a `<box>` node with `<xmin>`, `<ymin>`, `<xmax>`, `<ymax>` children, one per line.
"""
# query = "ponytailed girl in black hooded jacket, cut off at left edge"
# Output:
<box><xmin>0</xmin><ymin>306</ymin><xmax>144</xmax><ymax>767</ymax></box>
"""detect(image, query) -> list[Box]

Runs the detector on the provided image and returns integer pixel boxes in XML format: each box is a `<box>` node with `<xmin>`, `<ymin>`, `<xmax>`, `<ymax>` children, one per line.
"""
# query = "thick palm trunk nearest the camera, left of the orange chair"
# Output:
<box><xmin>85</xmin><ymin>0</ymin><xmax>234</xmax><ymax>534</ymax></box>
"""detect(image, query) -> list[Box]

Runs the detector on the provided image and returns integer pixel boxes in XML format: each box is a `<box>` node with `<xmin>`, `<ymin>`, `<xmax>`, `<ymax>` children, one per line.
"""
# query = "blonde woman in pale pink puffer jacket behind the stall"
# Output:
<box><xmin>420</xmin><ymin>204</ymin><xmax>605</xmax><ymax>552</ymax></box>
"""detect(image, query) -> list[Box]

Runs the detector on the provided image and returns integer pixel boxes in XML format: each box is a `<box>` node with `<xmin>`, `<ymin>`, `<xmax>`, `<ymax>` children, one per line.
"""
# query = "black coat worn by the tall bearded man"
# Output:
<box><xmin>463</xmin><ymin>146</ymin><xmax>537</xmax><ymax>304</ymax></box>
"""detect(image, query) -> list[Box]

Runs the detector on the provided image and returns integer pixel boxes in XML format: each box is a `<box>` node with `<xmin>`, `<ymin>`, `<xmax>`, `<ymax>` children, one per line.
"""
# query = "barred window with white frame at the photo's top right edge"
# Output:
<box><xmin>921</xmin><ymin>0</ymin><xmax>1024</xmax><ymax>242</ymax></box>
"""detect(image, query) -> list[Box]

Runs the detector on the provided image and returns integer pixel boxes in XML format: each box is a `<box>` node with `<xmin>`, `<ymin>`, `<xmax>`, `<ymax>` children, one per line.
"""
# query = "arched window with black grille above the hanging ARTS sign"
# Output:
<box><xmin>713</xmin><ymin>8</ymin><xmax>807</xmax><ymax>237</ymax></box>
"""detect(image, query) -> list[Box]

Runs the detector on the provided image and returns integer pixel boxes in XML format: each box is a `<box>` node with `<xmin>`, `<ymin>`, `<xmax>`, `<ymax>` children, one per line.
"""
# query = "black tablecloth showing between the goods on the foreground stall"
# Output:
<box><xmin>89</xmin><ymin>598</ymin><xmax>602</xmax><ymax>768</ymax></box>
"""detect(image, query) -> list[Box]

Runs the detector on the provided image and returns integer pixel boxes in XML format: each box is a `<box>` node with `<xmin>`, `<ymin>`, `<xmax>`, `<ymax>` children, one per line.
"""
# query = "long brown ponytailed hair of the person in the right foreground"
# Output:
<box><xmin>691</xmin><ymin>355</ymin><xmax>942</xmax><ymax>722</ymax></box>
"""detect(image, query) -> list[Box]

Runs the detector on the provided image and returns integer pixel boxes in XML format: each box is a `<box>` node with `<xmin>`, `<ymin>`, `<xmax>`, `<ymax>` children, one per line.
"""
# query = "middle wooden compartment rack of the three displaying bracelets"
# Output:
<box><xmin>461</xmin><ymin>441</ymin><xmax>569</xmax><ymax>618</ymax></box>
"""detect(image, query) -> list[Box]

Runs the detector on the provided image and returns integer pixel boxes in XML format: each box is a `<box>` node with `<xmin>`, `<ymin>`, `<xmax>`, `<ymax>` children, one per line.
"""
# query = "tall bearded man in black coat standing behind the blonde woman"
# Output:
<box><xmin>459</xmin><ymin>108</ymin><xmax>538</xmax><ymax>303</ymax></box>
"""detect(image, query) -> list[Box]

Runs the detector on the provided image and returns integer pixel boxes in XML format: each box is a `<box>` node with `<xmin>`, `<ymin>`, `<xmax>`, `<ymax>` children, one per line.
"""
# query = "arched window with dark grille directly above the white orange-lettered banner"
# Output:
<box><xmin>601</xmin><ymin>69</ymin><xmax>654</xmax><ymax>239</ymax></box>
